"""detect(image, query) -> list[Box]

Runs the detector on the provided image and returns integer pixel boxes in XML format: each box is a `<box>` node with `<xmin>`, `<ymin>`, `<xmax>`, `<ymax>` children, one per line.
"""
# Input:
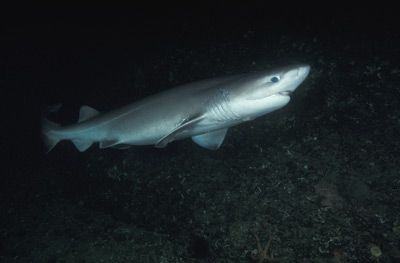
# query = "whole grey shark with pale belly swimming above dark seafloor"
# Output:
<box><xmin>42</xmin><ymin>65</ymin><xmax>310</xmax><ymax>151</ymax></box>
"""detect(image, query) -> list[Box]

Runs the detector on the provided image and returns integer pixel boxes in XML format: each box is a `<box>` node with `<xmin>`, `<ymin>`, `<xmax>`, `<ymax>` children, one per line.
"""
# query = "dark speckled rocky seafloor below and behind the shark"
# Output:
<box><xmin>0</xmin><ymin>31</ymin><xmax>400</xmax><ymax>263</ymax></box>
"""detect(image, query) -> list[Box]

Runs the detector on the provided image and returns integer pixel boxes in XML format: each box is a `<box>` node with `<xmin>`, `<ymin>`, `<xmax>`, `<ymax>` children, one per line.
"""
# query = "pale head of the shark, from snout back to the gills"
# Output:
<box><xmin>230</xmin><ymin>65</ymin><xmax>310</xmax><ymax>120</ymax></box>
